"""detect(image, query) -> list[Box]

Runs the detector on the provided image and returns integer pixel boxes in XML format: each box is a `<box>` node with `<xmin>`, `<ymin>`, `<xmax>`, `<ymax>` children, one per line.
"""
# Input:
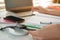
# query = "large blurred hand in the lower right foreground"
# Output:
<box><xmin>29</xmin><ymin>24</ymin><xmax>60</xmax><ymax>40</ymax></box>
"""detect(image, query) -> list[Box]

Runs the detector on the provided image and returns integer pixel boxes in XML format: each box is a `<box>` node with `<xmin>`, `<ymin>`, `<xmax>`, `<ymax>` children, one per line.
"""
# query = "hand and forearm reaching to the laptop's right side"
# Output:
<box><xmin>32</xmin><ymin>7</ymin><xmax>60</xmax><ymax>16</ymax></box>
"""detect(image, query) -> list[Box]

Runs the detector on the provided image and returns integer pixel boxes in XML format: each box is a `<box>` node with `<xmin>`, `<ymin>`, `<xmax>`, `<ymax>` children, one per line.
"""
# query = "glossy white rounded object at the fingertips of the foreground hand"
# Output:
<box><xmin>5</xmin><ymin>28</ymin><xmax>28</xmax><ymax>36</ymax></box>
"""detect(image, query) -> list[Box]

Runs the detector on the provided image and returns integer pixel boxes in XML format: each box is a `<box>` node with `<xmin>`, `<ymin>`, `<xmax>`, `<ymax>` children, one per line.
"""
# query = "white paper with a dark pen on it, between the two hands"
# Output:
<box><xmin>25</xmin><ymin>12</ymin><xmax>60</xmax><ymax>28</ymax></box>
